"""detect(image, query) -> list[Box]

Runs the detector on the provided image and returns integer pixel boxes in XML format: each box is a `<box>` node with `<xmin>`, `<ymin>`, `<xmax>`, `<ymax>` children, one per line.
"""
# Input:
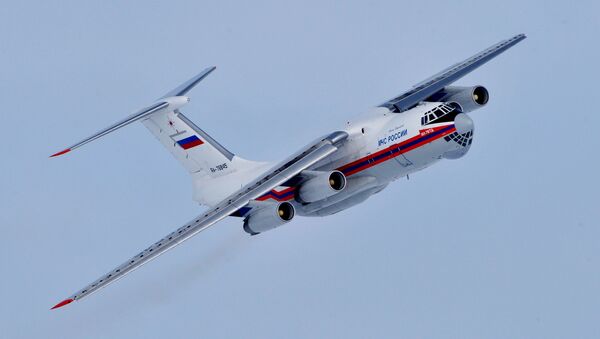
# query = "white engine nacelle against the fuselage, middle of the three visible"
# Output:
<box><xmin>298</xmin><ymin>171</ymin><xmax>346</xmax><ymax>202</ymax></box>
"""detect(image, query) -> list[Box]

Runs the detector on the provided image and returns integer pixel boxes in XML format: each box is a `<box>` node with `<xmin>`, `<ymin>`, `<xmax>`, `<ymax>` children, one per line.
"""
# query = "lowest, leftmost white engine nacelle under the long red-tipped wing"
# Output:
<box><xmin>244</xmin><ymin>202</ymin><xmax>296</xmax><ymax>235</ymax></box>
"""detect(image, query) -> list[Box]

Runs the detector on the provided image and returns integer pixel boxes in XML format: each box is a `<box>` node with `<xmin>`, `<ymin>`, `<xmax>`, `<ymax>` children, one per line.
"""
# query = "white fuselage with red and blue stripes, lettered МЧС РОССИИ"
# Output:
<box><xmin>199</xmin><ymin>102</ymin><xmax>473</xmax><ymax>216</ymax></box>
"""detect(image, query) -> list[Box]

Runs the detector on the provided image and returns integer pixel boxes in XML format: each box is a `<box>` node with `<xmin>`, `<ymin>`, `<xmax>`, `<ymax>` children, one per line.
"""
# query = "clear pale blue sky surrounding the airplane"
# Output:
<box><xmin>0</xmin><ymin>1</ymin><xmax>600</xmax><ymax>339</ymax></box>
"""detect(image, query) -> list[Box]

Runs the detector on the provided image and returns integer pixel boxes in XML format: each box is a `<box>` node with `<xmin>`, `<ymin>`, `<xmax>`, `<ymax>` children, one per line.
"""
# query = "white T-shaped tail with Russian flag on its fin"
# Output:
<box><xmin>50</xmin><ymin>66</ymin><xmax>268</xmax><ymax>206</ymax></box>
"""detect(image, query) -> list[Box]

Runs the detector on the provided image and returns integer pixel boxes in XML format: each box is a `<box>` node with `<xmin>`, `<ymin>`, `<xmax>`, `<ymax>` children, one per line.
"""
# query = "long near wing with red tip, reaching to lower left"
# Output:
<box><xmin>52</xmin><ymin>132</ymin><xmax>348</xmax><ymax>309</ymax></box>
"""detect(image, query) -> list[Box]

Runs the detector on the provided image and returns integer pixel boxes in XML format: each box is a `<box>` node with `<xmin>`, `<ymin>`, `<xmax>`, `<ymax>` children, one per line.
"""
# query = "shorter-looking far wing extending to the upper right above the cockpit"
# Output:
<box><xmin>379</xmin><ymin>34</ymin><xmax>526</xmax><ymax>113</ymax></box>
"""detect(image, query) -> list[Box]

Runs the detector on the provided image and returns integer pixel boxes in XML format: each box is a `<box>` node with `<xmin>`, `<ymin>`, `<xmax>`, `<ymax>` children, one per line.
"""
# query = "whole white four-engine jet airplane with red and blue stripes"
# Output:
<box><xmin>50</xmin><ymin>34</ymin><xmax>526</xmax><ymax>309</ymax></box>
